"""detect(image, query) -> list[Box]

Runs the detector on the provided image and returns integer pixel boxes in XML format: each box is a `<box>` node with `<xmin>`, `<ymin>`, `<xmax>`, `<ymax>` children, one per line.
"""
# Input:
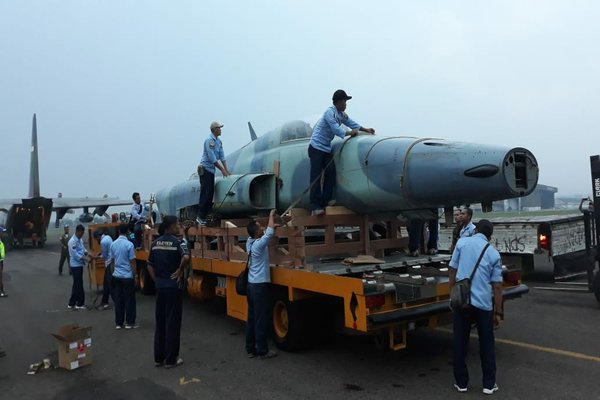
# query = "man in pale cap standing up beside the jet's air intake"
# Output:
<box><xmin>196</xmin><ymin>121</ymin><xmax>231</xmax><ymax>226</ymax></box>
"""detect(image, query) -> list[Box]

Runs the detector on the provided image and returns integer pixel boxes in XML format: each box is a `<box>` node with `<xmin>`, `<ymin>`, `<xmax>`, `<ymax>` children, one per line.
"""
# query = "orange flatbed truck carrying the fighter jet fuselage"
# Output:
<box><xmin>90</xmin><ymin>208</ymin><xmax>529</xmax><ymax>351</ymax></box>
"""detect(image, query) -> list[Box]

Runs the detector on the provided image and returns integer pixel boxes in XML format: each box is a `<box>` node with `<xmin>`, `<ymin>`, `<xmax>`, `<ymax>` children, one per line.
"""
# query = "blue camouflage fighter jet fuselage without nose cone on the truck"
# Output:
<box><xmin>156</xmin><ymin>121</ymin><xmax>539</xmax><ymax>223</ymax></box>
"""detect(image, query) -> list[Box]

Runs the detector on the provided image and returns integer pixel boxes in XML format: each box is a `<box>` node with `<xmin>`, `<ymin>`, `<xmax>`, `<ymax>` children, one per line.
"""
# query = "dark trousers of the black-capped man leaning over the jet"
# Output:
<box><xmin>308</xmin><ymin>145</ymin><xmax>335</xmax><ymax>210</ymax></box>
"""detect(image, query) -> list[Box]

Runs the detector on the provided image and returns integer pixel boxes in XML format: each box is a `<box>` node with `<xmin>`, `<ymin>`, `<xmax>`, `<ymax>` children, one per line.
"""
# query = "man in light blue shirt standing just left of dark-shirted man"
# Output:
<box><xmin>110</xmin><ymin>224</ymin><xmax>138</xmax><ymax>329</ymax></box>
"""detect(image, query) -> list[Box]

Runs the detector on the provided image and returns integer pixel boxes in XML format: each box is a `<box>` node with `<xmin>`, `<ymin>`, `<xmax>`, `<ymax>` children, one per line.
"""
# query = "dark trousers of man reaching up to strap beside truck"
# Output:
<box><xmin>246</xmin><ymin>283</ymin><xmax>271</xmax><ymax>355</ymax></box>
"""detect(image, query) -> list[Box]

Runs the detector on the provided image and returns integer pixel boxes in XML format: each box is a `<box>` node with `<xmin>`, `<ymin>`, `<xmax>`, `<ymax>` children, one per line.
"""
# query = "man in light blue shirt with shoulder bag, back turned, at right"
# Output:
<box><xmin>449</xmin><ymin>219</ymin><xmax>504</xmax><ymax>394</ymax></box>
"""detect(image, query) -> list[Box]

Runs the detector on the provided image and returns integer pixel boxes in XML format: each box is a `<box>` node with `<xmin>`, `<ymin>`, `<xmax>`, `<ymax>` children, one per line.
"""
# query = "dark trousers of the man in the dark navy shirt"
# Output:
<box><xmin>154</xmin><ymin>288</ymin><xmax>183</xmax><ymax>365</ymax></box>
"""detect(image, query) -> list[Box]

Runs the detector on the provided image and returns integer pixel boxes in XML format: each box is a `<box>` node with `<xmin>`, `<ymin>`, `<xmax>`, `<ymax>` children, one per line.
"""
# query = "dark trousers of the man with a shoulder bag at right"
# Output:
<box><xmin>452</xmin><ymin>307</ymin><xmax>496</xmax><ymax>389</ymax></box>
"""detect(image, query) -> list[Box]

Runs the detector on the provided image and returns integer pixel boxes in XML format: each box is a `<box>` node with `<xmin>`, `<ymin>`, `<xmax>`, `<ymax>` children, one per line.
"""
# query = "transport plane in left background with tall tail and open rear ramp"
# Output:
<box><xmin>0</xmin><ymin>114</ymin><xmax>131</xmax><ymax>247</ymax></box>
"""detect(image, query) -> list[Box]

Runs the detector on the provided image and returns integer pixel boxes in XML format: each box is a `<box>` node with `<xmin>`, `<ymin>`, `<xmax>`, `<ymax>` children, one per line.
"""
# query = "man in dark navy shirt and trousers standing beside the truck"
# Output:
<box><xmin>148</xmin><ymin>215</ymin><xmax>190</xmax><ymax>368</ymax></box>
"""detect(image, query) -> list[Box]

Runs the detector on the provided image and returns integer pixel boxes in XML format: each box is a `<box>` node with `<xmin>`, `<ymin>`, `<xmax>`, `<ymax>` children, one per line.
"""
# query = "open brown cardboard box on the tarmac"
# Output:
<box><xmin>52</xmin><ymin>324</ymin><xmax>92</xmax><ymax>370</ymax></box>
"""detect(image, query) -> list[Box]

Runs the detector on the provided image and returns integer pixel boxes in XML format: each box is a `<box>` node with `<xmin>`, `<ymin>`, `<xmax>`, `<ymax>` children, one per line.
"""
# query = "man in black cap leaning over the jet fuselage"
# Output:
<box><xmin>308</xmin><ymin>89</ymin><xmax>375</xmax><ymax>215</ymax></box>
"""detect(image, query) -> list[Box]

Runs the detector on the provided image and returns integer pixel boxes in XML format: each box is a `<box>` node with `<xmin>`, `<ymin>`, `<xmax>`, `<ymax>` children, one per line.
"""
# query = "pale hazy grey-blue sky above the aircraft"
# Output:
<box><xmin>0</xmin><ymin>0</ymin><xmax>600</xmax><ymax>198</ymax></box>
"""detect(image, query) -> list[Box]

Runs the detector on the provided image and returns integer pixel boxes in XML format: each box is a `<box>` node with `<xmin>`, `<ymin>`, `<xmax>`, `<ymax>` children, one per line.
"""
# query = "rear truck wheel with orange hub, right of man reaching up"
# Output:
<box><xmin>273</xmin><ymin>299</ymin><xmax>309</xmax><ymax>351</ymax></box>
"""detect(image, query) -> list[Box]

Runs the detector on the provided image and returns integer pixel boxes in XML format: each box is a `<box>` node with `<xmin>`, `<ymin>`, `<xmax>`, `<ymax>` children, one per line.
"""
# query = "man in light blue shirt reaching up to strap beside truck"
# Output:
<box><xmin>246</xmin><ymin>210</ymin><xmax>277</xmax><ymax>359</ymax></box>
